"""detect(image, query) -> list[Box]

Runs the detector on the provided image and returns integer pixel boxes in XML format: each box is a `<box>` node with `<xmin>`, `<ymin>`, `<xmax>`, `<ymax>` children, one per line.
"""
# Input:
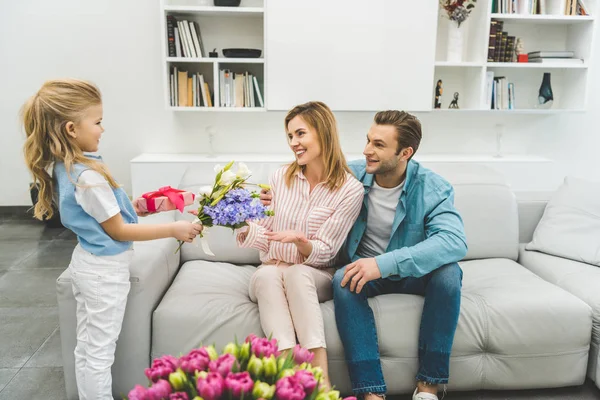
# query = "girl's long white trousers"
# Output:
<box><xmin>69</xmin><ymin>245</ymin><xmax>133</xmax><ymax>400</ymax></box>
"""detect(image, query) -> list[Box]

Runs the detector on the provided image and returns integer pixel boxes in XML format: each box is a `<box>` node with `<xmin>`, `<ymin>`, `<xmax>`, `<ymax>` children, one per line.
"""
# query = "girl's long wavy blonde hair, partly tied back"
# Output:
<box><xmin>21</xmin><ymin>79</ymin><xmax>118</xmax><ymax>220</ymax></box>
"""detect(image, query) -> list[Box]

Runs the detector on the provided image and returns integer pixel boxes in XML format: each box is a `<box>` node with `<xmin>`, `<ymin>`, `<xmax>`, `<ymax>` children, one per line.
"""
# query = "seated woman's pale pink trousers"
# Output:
<box><xmin>249</xmin><ymin>262</ymin><xmax>333</xmax><ymax>350</ymax></box>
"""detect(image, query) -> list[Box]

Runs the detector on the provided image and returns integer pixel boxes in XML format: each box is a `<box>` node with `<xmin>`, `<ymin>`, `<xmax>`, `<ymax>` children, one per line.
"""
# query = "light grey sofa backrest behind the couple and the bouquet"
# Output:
<box><xmin>176</xmin><ymin>158</ymin><xmax>519</xmax><ymax>264</ymax></box>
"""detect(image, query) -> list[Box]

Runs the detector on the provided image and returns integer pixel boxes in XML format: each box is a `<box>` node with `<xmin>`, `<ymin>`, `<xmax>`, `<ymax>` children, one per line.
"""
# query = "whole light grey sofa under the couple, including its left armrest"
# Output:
<box><xmin>57</xmin><ymin>162</ymin><xmax>596</xmax><ymax>399</ymax></box>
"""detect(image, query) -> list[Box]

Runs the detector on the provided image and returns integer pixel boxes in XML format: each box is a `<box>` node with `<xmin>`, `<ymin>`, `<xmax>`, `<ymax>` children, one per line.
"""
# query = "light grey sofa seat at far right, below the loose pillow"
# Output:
<box><xmin>519</xmin><ymin>245</ymin><xmax>600</xmax><ymax>344</ymax></box>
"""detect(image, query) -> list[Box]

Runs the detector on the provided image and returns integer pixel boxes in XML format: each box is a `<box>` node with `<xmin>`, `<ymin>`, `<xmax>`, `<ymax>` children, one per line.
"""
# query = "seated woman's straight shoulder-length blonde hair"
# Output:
<box><xmin>285</xmin><ymin>101</ymin><xmax>350</xmax><ymax>190</ymax></box>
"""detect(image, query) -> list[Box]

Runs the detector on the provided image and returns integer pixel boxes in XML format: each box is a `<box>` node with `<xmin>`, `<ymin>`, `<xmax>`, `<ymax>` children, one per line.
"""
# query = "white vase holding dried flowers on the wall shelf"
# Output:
<box><xmin>440</xmin><ymin>0</ymin><xmax>477</xmax><ymax>62</ymax></box>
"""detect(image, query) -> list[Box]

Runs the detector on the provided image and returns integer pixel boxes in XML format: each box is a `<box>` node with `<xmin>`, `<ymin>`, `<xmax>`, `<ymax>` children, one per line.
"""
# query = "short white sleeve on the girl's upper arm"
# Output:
<box><xmin>75</xmin><ymin>169</ymin><xmax>121</xmax><ymax>224</ymax></box>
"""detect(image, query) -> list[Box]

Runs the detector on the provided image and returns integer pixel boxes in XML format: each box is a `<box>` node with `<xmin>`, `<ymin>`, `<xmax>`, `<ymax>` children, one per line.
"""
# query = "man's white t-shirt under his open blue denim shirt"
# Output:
<box><xmin>357</xmin><ymin>180</ymin><xmax>404</xmax><ymax>258</ymax></box>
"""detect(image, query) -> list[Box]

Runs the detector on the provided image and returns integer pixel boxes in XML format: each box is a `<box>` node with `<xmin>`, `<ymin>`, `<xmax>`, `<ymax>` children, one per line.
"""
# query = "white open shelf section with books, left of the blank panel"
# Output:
<box><xmin>160</xmin><ymin>0</ymin><xmax>267</xmax><ymax>113</ymax></box>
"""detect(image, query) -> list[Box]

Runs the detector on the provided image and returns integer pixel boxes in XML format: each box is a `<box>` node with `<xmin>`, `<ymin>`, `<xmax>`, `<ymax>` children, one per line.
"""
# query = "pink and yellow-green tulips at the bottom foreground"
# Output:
<box><xmin>127</xmin><ymin>335</ymin><xmax>356</xmax><ymax>400</ymax></box>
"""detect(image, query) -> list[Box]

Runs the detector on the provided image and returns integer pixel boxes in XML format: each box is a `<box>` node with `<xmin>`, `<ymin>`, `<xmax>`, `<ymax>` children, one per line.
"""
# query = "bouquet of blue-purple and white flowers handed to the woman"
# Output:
<box><xmin>176</xmin><ymin>161</ymin><xmax>274</xmax><ymax>255</ymax></box>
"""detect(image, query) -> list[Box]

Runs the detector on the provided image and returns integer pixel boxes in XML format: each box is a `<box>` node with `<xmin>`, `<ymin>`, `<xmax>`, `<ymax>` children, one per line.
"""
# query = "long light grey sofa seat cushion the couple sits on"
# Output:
<box><xmin>152</xmin><ymin>259</ymin><xmax>592</xmax><ymax>393</ymax></box>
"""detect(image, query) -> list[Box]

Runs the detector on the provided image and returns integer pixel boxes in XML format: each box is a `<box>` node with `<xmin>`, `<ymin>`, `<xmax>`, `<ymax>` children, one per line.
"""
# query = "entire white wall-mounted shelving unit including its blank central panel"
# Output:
<box><xmin>160</xmin><ymin>0</ymin><xmax>600</xmax><ymax>115</ymax></box>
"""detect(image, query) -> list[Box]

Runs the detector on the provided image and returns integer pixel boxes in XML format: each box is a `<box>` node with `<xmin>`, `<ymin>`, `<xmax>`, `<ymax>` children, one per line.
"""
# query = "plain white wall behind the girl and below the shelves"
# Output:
<box><xmin>0</xmin><ymin>0</ymin><xmax>600</xmax><ymax>206</ymax></box>
